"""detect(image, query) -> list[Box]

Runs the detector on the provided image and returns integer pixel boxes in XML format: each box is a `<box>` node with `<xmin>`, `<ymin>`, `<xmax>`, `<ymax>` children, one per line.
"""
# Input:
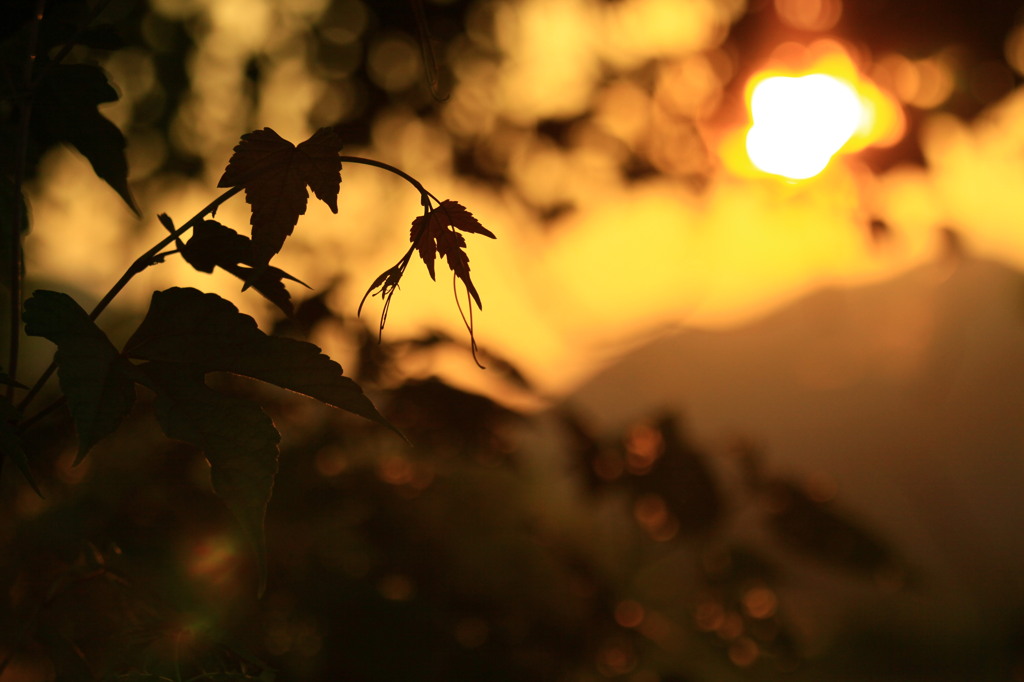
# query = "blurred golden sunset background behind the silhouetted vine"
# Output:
<box><xmin>6</xmin><ymin>0</ymin><xmax>1024</xmax><ymax>682</ymax></box>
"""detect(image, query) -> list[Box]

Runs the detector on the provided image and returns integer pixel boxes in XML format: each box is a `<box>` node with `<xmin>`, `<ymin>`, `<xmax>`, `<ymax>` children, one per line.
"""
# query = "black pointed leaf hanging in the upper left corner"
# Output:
<box><xmin>33</xmin><ymin>63</ymin><xmax>138</xmax><ymax>214</ymax></box>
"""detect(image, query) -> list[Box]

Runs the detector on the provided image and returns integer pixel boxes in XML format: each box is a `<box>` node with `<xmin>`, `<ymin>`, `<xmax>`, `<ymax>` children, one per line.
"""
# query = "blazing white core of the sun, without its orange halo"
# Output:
<box><xmin>746</xmin><ymin>74</ymin><xmax>866</xmax><ymax>180</ymax></box>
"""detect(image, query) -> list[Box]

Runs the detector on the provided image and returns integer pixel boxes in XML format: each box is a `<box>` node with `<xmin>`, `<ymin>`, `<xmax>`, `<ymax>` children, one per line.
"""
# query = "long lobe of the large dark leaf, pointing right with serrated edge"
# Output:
<box><xmin>124</xmin><ymin>288</ymin><xmax>394</xmax><ymax>436</ymax></box>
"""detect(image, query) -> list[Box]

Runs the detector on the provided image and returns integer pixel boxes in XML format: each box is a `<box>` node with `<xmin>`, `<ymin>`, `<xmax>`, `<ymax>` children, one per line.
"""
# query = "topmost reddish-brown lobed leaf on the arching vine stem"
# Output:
<box><xmin>217</xmin><ymin>128</ymin><xmax>341</xmax><ymax>266</ymax></box>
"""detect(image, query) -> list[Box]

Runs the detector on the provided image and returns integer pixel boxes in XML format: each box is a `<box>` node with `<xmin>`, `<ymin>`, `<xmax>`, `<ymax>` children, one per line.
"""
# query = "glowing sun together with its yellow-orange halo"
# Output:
<box><xmin>723</xmin><ymin>40</ymin><xmax>905</xmax><ymax>180</ymax></box>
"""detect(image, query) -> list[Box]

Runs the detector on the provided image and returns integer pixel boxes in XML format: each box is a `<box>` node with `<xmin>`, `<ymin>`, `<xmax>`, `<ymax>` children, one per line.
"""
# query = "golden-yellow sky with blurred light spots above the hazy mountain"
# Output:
<box><xmin>29</xmin><ymin>0</ymin><xmax>1024</xmax><ymax>393</ymax></box>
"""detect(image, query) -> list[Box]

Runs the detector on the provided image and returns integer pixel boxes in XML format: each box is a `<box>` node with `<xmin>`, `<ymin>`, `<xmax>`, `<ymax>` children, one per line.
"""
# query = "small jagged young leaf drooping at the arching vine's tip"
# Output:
<box><xmin>409</xmin><ymin>199</ymin><xmax>495</xmax><ymax>309</ymax></box>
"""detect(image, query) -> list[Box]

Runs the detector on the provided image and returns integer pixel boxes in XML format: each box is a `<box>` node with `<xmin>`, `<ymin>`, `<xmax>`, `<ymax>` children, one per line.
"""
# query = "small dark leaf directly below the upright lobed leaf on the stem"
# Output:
<box><xmin>178</xmin><ymin>220</ymin><xmax>309</xmax><ymax>316</ymax></box>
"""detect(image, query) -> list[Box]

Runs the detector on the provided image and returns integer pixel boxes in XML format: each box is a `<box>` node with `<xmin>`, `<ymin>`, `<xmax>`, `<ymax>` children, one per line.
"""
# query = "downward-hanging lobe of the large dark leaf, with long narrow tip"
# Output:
<box><xmin>137</xmin><ymin>363</ymin><xmax>281</xmax><ymax>594</ymax></box>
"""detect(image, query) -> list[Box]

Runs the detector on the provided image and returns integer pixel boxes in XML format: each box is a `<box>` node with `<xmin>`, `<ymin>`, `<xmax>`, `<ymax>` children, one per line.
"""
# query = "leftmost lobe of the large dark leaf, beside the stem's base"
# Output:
<box><xmin>24</xmin><ymin>291</ymin><xmax>135</xmax><ymax>464</ymax></box>
